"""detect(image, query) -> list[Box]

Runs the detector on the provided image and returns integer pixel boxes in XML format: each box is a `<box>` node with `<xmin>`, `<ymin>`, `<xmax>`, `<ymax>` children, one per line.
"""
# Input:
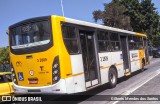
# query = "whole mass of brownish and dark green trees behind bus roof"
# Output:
<box><xmin>93</xmin><ymin>0</ymin><xmax>160</xmax><ymax>46</ymax></box>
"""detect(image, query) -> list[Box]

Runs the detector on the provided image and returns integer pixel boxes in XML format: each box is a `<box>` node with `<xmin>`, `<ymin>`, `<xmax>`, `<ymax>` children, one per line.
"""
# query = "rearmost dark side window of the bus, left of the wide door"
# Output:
<box><xmin>62</xmin><ymin>25</ymin><xmax>79</xmax><ymax>54</ymax></box>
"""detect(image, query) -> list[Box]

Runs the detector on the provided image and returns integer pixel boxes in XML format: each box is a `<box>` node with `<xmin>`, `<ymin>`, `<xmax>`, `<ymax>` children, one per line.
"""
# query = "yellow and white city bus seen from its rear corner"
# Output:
<box><xmin>9</xmin><ymin>15</ymin><xmax>149</xmax><ymax>94</ymax></box>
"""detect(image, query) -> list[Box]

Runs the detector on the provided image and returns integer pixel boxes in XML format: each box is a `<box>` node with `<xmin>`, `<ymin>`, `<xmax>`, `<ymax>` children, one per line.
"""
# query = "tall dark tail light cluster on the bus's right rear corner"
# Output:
<box><xmin>52</xmin><ymin>56</ymin><xmax>60</xmax><ymax>84</ymax></box>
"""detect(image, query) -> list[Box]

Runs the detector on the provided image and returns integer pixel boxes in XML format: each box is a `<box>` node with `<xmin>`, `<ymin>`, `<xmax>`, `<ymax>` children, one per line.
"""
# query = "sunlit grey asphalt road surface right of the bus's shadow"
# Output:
<box><xmin>80</xmin><ymin>58</ymin><xmax>160</xmax><ymax>104</ymax></box>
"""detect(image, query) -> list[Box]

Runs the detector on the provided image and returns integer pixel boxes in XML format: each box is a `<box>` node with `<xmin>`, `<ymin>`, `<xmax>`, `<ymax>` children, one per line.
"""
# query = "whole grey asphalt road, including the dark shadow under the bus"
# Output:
<box><xmin>1</xmin><ymin>58</ymin><xmax>160</xmax><ymax>104</ymax></box>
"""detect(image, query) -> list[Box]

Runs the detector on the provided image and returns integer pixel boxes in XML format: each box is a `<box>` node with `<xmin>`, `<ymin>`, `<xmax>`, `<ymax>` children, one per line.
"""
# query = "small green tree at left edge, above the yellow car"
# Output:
<box><xmin>0</xmin><ymin>47</ymin><xmax>9</xmax><ymax>71</ymax></box>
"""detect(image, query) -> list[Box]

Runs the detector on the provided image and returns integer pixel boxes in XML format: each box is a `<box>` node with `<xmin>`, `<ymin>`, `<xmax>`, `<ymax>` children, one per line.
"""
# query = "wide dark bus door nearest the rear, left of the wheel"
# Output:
<box><xmin>79</xmin><ymin>30</ymin><xmax>99</xmax><ymax>88</ymax></box>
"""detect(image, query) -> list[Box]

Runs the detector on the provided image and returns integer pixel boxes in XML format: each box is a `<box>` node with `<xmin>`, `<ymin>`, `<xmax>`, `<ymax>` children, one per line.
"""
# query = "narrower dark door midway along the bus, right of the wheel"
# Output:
<box><xmin>120</xmin><ymin>36</ymin><xmax>131</xmax><ymax>75</ymax></box>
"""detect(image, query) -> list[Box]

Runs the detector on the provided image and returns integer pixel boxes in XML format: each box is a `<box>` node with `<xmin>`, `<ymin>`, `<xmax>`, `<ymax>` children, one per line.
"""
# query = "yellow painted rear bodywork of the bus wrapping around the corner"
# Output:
<box><xmin>10</xmin><ymin>16</ymin><xmax>72</xmax><ymax>87</ymax></box>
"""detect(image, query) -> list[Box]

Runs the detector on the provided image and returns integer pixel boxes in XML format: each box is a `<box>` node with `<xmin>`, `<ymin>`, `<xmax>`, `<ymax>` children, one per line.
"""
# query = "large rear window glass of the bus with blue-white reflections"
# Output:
<box><xmin>10</xmin><ymin>21</ymin><xmax>51</xmax><ymax>49</ymax></box>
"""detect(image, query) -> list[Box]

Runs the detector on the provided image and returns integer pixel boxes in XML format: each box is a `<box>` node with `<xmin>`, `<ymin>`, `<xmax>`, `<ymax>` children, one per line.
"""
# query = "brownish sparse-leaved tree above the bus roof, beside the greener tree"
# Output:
<box><xmin>92</xmin><ymin>0</ymin><xmax>131</xmax><ymax>30</ymax></box>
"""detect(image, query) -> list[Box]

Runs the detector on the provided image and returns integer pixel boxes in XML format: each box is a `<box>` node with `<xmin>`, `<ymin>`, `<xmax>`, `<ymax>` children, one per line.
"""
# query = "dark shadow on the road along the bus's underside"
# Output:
<box><xmin>2</xmin><ymin>69</ymin><xmax>147</xmax><ymax>104</ymax></box>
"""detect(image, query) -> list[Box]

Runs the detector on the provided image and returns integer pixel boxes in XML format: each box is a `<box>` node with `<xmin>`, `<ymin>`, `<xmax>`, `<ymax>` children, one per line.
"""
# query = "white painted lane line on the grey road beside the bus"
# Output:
<box><xmin>107</xmin><ymin>69</ymin><xmax>160</xmax><ymax>104</ymax></box>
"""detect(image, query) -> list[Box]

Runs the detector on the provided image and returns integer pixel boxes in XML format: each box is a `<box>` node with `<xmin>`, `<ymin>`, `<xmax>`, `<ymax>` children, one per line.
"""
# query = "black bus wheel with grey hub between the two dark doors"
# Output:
<box><xmin>108</xmin><ymin>67</ymin><xmax>117</xmax><ymax>88</ymax></box>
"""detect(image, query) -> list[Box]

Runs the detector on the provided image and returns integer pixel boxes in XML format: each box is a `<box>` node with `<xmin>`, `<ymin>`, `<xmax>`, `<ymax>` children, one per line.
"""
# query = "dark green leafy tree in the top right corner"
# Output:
<box><xmin>119</xmin><ymin>0</ymin><xmax>159</xmax><ymax>44</ymax></box>
